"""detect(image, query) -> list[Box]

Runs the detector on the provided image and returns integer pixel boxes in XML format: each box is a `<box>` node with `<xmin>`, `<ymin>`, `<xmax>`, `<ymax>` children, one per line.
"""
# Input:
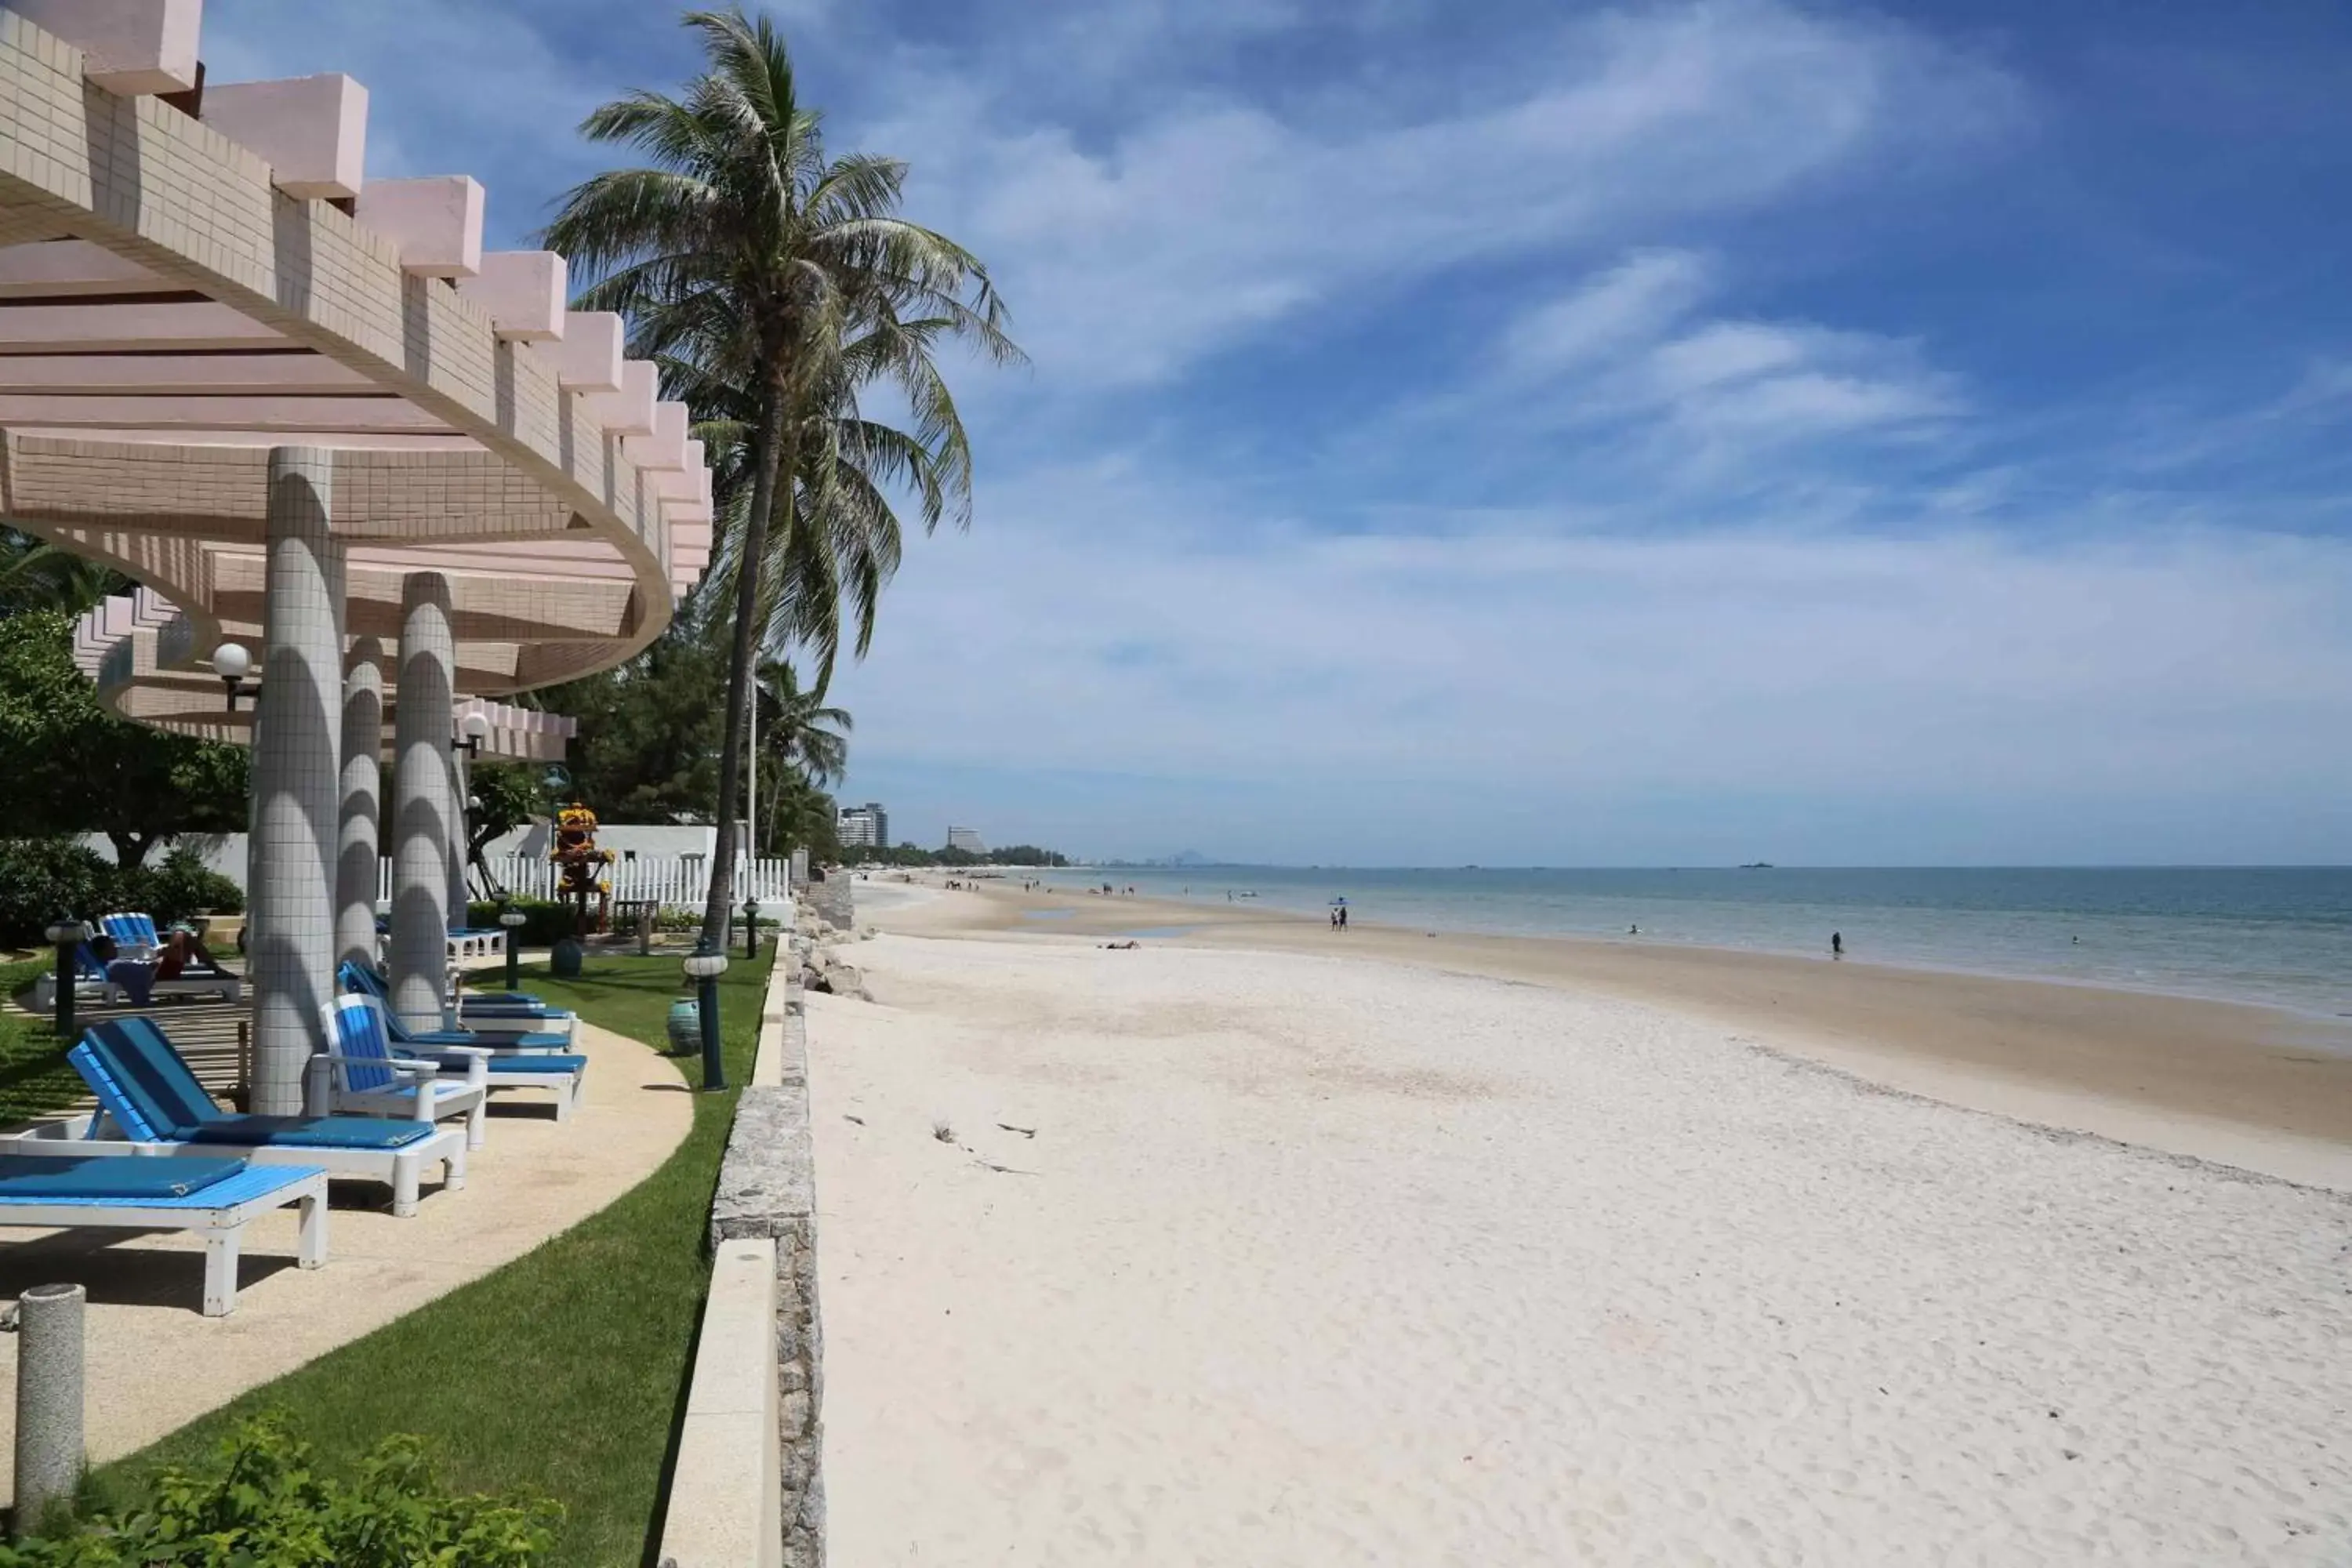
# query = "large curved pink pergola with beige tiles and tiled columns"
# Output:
<box><xmin>0</xmin><ymin>0</ymin><xmax>713</xmax><ymax>1114</ymax></box>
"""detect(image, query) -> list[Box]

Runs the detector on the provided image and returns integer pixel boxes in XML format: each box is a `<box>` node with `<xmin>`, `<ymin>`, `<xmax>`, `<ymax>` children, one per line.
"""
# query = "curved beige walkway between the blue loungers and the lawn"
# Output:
<box><xmin>0</xmin><ymin>1022</ymin><xmax>694</xmax><ymax>1502</ymax></box>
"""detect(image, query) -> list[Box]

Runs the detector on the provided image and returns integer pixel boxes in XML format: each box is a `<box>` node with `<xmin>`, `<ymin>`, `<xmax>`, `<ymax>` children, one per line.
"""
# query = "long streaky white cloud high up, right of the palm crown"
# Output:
<box><xmin>866</xmin><ymin>5</ymin><xmax>2016</xmax><ymax>386</ymax></box>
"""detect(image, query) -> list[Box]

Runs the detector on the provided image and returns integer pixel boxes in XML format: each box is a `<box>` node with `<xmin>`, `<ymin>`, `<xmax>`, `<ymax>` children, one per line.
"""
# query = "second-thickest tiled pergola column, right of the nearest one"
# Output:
<box><xmin>393</xmin><ymin>572</ymin><xmax>456</xmax><ymax>1029</ymax></box>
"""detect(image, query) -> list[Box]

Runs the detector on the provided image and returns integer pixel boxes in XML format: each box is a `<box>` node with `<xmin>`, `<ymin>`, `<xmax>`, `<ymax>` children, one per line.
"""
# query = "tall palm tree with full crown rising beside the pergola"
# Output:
<box><xmin>546</xmin><ymin>9</ymin><xmax>1021</xmax><ymax>942</ymax></box>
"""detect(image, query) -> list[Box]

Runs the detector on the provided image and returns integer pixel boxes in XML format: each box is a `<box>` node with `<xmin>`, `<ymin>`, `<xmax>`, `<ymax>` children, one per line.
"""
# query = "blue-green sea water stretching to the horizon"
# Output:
<box><xmin>1047</xmin><ymin>865</ymin><xmax>2352</xmax><ymax>1018</ymax></box>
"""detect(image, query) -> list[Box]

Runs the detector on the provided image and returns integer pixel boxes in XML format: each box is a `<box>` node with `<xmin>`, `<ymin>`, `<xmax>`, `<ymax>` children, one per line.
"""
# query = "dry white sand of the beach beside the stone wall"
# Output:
<box><xmin>809</xmin><ymin>935</ymin><xmax>2352</xmax><ymax>1568</ymax></box>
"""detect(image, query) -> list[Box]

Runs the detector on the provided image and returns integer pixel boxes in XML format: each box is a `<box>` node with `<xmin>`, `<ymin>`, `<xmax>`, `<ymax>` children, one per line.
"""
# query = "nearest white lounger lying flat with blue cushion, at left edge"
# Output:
<box><xmin>0</xmin><ymin>1154</ymin><xmax>327</xmax><ymax>1316</ymax></box>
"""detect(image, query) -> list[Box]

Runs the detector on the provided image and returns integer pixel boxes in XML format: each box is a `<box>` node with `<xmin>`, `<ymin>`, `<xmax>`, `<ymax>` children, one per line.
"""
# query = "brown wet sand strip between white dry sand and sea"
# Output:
<box><xmin>861</xmin><ymin>877</ymin><xmax>2352</xmax><ymax>1192</ymax></box>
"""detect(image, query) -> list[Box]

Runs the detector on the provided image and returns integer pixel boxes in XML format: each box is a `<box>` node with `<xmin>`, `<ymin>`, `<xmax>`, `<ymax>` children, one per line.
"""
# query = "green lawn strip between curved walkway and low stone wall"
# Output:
<box><xmin>94</xmin><ymin>956</ymin><xmax>767</xmax><ymax>1566</ymax></box>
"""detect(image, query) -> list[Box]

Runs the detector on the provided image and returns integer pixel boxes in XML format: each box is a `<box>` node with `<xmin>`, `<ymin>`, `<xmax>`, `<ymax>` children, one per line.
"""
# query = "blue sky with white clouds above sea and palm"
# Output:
<box><xmin>207</xmin><ymin>0</ymin><xmax>2352</xmax><ymax>865</ymax></box>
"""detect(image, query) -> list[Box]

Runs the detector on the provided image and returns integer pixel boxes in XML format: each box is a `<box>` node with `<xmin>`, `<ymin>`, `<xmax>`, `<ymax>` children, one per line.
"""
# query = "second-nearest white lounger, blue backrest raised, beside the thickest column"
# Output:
<box><xmin>0</xmin><ymin>1018</ymin><xmax>466</xmax><ymax>1215</ymax></box>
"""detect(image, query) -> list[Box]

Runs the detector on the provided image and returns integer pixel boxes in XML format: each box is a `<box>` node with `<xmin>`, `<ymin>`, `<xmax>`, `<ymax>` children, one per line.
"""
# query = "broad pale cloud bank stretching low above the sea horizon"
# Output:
<box><xmin>842</xmin><ymin>453</ymin><xmax>2352</xmax><ymax>827</ymax></box>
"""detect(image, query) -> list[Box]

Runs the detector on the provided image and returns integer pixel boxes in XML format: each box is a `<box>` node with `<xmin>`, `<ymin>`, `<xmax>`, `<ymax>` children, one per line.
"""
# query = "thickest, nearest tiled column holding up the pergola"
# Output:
<box><xmin>245</xmin><ymin>447</ymin><xmax>343</xmax><ymax>1116</ymax></box>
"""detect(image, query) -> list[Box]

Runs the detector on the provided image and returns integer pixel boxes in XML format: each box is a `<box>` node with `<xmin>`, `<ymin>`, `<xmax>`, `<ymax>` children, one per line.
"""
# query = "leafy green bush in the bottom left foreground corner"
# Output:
<box><xmin>0</xmin><ymin>1413</ymin><xmax>564</xmax><ymax>1568</ymax></box>
